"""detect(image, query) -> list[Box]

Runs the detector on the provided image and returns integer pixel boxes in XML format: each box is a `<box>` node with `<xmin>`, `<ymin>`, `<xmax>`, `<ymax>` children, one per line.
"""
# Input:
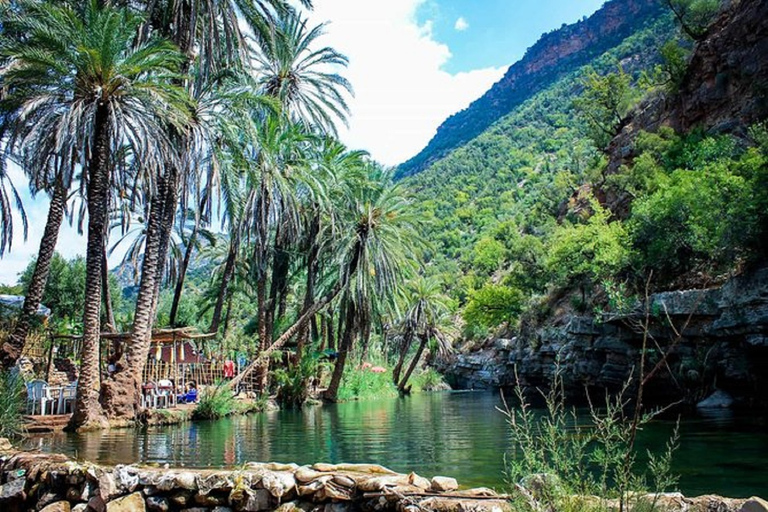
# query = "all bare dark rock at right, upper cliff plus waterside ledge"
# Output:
<box><xmin>442</xmin><ymin>0</ymin><xmax>768</xmax><ymax>406</ymax></box>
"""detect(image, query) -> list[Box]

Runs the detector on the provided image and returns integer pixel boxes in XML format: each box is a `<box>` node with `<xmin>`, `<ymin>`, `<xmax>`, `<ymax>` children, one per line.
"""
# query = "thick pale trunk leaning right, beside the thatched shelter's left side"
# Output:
<box><xmin>102</xmin><ymin>177</ymin><xmax>167</xmax><ymax>419</ymax></box>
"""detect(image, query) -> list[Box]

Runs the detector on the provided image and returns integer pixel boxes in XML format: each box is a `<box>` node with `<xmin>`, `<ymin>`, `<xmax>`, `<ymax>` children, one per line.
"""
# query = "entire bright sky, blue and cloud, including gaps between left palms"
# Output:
<box><xmin>0</xmin><ymin>0</ymin><xmax>604</xmax><ymax>284</ymax></box>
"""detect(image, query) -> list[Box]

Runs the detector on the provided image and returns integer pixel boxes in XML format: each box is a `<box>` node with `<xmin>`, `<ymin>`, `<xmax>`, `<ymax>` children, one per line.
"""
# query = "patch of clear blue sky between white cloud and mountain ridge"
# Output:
<box><xmin>416</xmin><ymin>0</ymin><xmax>604</xmax><ymax>73</ymax></box>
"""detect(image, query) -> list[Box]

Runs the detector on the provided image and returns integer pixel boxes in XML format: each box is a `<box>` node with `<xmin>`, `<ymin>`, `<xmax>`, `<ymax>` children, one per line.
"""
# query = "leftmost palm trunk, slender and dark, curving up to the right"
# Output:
<box><xmin>0</xmin><ymin>183</ymin><xmax>67</xmax><ymax>368</ymax></box>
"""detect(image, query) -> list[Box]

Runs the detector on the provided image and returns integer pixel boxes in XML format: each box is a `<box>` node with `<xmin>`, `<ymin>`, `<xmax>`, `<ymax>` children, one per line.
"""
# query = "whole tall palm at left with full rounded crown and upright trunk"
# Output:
<box><xmin>4</xmin><ymin>0</ymin><xmax>187</xmax><ymax>428</ymax></box>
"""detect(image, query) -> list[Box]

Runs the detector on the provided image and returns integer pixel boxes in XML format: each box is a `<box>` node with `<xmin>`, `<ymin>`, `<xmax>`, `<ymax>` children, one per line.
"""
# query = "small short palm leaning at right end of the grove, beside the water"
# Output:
<box><xmin>393</xmin><ymin>276</ymin><xmax>452</xmax><ymax>393</ymax></box>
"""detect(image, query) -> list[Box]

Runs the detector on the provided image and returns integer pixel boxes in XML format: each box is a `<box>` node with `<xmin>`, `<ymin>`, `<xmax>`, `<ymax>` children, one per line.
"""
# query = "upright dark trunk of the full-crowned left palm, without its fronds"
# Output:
<box><xmin>69</xmin><ymin>104</ymin><xmax>110</xmax><ymax>430</ymax></box>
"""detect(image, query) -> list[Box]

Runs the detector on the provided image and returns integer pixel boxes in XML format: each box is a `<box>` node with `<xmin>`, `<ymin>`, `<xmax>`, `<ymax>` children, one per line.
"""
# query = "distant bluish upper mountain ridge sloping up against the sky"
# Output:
<box><xmin>397</xmin><ymin>0</ymin><xmax>665</xmax><ymax>177</ymax></box>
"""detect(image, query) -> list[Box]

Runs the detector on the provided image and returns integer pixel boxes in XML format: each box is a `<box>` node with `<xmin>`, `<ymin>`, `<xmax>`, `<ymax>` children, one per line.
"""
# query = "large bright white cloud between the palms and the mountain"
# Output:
<box><xmin>304</xmin><ymin>0</ymin><xmax>505</xmax><ymax>165</ymax></box>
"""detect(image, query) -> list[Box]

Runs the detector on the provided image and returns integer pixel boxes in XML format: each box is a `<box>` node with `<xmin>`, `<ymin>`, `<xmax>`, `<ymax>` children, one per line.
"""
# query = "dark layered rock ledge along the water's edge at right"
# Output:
<box><xmin>441</xmin><ymin>268</ymin><xmax>768</xmax><ymax>406</ymax></box>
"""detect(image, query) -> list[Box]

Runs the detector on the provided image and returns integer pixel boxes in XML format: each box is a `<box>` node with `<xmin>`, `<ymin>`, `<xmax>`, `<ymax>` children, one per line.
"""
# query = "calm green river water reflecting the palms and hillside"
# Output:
<box><xmin>28</xmin><ymin>393</ymin><xmax>768</xmax><ymax>497</ymax></box>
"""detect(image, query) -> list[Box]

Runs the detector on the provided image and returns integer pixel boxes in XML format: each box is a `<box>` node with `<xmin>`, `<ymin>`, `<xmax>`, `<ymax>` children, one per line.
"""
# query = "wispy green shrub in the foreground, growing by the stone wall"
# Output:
<box><xmin>502</xmin><ymin>368</ymin><xmax>678</xmax><ymax>512</ymax></box>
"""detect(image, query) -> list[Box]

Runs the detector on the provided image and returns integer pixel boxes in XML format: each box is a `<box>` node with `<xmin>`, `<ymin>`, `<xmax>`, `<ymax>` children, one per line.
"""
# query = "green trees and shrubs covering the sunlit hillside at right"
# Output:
<box><xmin>405</xmin><ymin>2</ymin><xmax>768</xmax><ymax>338</ymax></box>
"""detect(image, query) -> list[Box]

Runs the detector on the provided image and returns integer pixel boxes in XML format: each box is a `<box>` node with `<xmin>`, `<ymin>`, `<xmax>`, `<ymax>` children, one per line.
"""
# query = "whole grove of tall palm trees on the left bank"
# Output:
<box><xmin>0</xmin><ymin>0</ymin><xmax>456</xmax><ymax>429</ymax></box>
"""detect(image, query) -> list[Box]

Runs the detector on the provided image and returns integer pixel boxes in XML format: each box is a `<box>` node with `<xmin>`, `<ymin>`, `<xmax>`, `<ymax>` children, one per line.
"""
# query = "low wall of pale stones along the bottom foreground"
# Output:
<box><xmin>0</xmin><ymin>446</ymin><xmax>768</xmax><ymax>512</ymax></box>
